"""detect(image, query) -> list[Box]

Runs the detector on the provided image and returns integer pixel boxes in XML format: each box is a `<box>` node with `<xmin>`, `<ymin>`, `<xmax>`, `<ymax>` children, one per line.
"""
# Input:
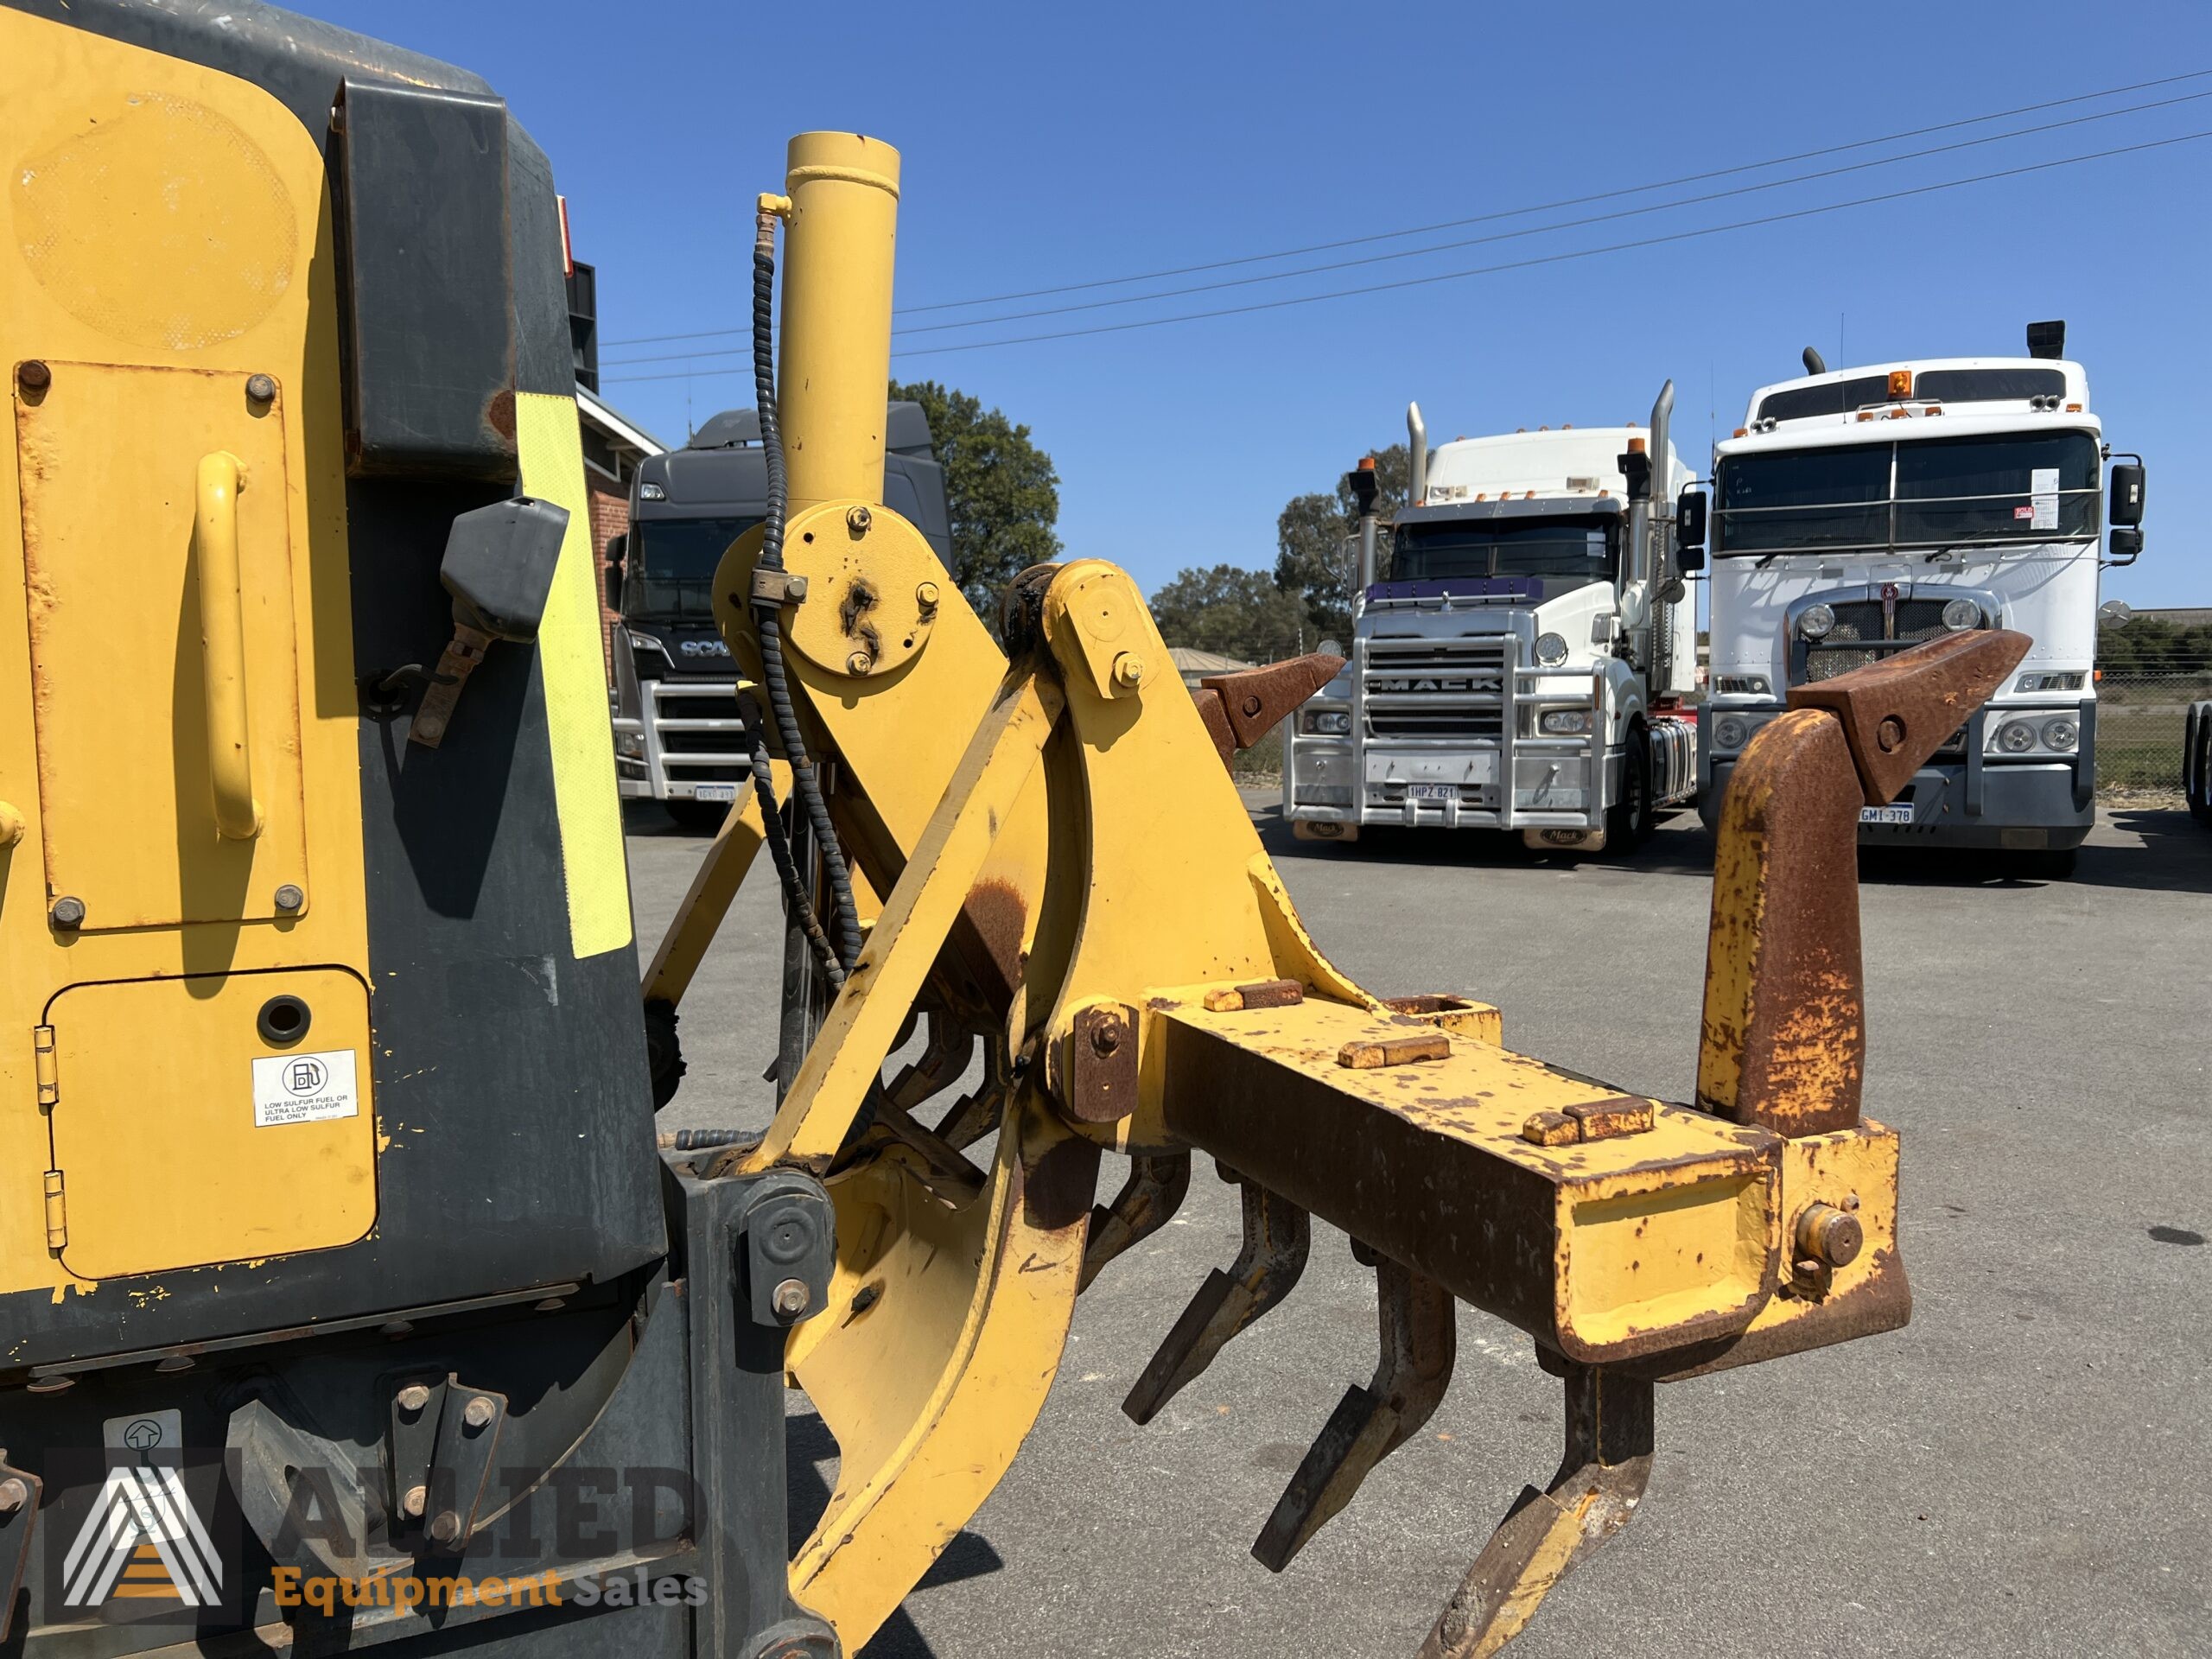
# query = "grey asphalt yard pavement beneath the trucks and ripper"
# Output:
<box><xmin>628</xmin><ymin>797</ymin><xmax>2212</xmax><ymax>1659</ymax></box>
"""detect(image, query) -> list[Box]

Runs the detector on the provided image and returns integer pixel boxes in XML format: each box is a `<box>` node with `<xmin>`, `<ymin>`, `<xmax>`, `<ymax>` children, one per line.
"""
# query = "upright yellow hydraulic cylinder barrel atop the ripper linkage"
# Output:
<box><xmin>777</xmin><ymin>133</ymin><xmax>898</xmax><ymax>518</ymax></box>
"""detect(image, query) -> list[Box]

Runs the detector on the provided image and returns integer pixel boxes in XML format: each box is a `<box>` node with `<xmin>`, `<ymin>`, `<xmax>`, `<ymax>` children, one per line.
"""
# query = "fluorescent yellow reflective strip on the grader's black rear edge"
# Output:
<box><xmin>515</xmin><ymin>391</ymin><xmax>631</xmax><ymax>957</ymax></box>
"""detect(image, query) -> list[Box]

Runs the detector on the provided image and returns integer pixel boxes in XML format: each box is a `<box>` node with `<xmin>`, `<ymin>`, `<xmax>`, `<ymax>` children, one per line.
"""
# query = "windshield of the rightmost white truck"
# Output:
<box><xmin>1714</xmin><ymin>431</ymin><xmax>2101</xmax><ymax>557</ymax></box>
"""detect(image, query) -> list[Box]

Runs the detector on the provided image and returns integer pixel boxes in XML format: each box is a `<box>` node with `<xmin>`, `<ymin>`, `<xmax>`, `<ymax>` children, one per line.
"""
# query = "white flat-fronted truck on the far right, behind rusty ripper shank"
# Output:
<box><xmin>1676</xmin><ymin>321</ymin><xmax>2144</xmax><ymax>878</ymax></box>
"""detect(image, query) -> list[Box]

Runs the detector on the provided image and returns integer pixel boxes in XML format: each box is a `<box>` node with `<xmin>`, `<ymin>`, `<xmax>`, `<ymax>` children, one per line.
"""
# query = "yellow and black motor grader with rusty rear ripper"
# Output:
<box><xmin>0</xmin><ymin>0</ymin><xmax>2024</xmax><ymax>1659</ymax></box>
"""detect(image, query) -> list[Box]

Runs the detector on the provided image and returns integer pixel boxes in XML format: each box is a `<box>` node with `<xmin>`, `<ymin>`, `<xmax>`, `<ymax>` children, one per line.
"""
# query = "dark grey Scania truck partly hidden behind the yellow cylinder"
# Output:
<box><xmin>606</xmin><ymin>403</ymin><xmax>951</xmax><ymax>825</ymax></box>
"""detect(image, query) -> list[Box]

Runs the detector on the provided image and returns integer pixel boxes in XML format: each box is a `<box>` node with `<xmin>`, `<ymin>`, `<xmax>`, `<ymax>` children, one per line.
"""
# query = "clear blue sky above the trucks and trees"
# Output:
<box><xmin>301</xmin><ymin>0</ymin><xmax>2212</xmax><ymax>606</ymax></box>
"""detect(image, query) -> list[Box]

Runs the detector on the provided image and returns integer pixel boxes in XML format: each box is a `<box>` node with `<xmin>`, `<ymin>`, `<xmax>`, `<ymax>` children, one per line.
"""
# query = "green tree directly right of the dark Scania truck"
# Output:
<box><xmin>892</xmin><ymin>380</ymin><xmax>1059</xmax><ymax>628</ymax></box>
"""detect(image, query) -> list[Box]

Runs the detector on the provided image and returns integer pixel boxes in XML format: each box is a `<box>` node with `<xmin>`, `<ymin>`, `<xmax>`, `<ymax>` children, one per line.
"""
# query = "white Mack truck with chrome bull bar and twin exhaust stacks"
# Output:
<box><xmin>1283</xmin><ymin>380</ymin><xmax>1697</xmax><ymax>854</ymax></box>
